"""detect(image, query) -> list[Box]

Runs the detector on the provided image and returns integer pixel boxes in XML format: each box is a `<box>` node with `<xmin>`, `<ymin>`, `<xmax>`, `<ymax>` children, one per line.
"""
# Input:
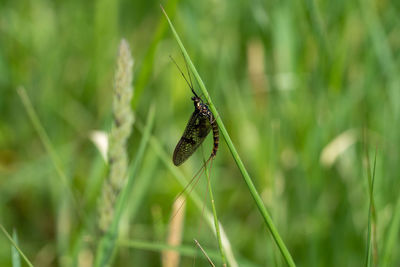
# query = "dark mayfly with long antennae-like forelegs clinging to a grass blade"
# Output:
<box><xmin>170</xmin><ymin>57</ymin><xmax>219</xmax><ymax>166</ymax></box>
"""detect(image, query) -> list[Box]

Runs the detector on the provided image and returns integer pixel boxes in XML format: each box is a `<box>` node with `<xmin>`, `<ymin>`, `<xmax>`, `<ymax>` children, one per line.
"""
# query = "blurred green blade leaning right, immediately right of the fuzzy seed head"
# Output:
<box><xmin>95</xmin><ymin>105</ymin><xmax>155</xmax><ymax>266</ymax></box>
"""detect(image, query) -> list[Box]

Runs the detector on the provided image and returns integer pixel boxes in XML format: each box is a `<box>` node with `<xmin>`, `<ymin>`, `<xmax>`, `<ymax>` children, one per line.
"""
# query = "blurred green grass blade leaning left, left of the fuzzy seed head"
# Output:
<box><xmin>17</xmin><ymin>86</ymin><xmax>82</xmax><ymax>219</ymax></box>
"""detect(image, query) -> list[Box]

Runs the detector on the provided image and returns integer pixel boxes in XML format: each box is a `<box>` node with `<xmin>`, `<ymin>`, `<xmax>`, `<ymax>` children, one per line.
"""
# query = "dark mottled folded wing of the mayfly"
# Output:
<box><xmin>172</xmin><ymin>110</ymin><xmax>211</xmax><ymax>166</ymax></box>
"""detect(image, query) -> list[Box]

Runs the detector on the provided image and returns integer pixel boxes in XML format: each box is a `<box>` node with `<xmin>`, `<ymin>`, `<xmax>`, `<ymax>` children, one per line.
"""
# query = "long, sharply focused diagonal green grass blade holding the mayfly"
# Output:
<box><xmin>161</xmin><ymin>6</ymin><xmax>296</xmax><ymax>266</ymax></box>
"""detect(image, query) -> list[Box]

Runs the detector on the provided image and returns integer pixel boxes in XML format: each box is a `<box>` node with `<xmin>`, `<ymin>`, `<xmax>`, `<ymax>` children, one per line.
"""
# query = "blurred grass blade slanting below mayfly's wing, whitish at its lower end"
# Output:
<box><xmin>135</xmin><ymin>120</ymin><xmax>238</xmax><ymax>267</ymax></box>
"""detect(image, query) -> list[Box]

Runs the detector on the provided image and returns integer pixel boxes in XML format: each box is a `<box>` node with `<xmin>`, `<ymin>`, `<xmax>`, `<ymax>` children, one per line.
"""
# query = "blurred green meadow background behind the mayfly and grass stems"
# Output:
<box><xmin>0</xmin><ymin>0</ymin><xmax>400</xmax><ymax>266</ymax></box>
